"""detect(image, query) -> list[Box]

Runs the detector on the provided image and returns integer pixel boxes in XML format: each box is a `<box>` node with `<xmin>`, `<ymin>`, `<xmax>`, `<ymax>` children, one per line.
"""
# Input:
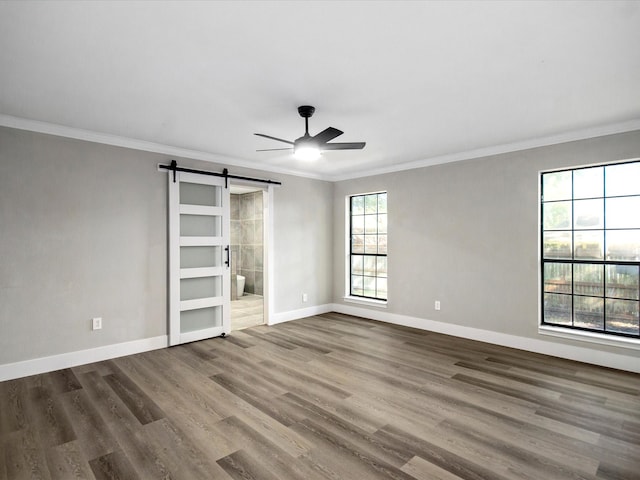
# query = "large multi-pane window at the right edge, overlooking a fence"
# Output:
<box><xmin>540</xmin><ymin>161</ymin><xmax>640</xmax><ymax>338</ymax></box>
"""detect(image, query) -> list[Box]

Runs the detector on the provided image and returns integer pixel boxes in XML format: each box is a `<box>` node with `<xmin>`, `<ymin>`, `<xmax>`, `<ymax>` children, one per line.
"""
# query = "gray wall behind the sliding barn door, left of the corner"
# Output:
<box><xmin>0</xmin><ymin>128</ymin><xmax>333</xmax><ymax>365</ymax></box>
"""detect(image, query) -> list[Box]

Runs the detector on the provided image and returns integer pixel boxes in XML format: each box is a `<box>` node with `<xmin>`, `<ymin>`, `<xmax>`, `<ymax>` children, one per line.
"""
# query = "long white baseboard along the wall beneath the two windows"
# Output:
<box><xmin>332</xmin><ymin>303</ymin><xmax>640</xmax><ymax>373</ymax></box>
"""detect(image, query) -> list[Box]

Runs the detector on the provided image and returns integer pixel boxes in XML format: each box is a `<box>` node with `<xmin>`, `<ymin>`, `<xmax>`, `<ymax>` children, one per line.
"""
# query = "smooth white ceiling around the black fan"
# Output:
<box><xmin>0</xmin><ymin>1</ymin><xmax>640</xmax><ymax>180</ymax></box>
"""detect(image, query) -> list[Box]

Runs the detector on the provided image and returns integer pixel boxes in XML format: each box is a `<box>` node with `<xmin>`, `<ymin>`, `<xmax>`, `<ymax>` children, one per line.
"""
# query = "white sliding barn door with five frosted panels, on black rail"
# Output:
<box><xmin>167</xmin><ymin>172</ymin><xmax>231</xmax><ymax>345</ymax></box>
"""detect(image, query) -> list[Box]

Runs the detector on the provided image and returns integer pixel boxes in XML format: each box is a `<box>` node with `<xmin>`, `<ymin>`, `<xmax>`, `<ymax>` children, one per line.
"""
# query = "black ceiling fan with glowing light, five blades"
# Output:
<box><xmin>255</xmin><ymin>105</ymin><xmax>366</xmax><ymax>160</ymax></box>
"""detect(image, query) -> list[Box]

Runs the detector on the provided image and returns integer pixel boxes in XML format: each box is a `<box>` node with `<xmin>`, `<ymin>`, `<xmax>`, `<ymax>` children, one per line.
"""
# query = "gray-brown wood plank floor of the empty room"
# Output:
<box><xmin>0</xmin><ymin>313</ymin><xmax>640</xmax><ymax>480</ymax></box>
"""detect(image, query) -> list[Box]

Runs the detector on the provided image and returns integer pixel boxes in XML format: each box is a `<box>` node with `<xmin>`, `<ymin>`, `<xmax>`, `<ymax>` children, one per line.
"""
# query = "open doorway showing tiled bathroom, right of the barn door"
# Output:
<box><xmin>230</xmin><ymin>183</ymin><xmax>268</xmax><ymax>330</ymax></box>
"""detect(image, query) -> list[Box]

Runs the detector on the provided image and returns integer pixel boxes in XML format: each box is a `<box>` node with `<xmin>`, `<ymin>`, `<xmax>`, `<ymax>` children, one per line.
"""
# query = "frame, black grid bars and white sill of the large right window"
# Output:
<box><xmin>538</xmin><ymin>158</ymin><xmax>640</xmax><ymax>349</ymax></box>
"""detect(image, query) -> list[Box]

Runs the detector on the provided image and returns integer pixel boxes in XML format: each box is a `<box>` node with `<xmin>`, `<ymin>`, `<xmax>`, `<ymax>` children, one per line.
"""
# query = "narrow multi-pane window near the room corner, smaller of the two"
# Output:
<box><xmin>349</xmin><ymin>192</ymin><xmax>387</xmax><ymax>301</ymax></box>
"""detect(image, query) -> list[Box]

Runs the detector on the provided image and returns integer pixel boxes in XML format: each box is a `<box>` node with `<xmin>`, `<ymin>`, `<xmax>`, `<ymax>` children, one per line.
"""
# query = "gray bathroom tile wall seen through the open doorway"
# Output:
<box><xmin>231</xmin><ymin>191</ymin><xmax>264</xmax><ymax>299</ymax></box>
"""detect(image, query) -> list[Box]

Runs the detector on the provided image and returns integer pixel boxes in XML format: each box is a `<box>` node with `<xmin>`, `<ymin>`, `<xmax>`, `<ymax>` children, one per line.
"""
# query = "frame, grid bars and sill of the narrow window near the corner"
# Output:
<box><xmin>344</xmin><ymin>190</ymin><xmax>389</xmax><ymax>308</ymax></box>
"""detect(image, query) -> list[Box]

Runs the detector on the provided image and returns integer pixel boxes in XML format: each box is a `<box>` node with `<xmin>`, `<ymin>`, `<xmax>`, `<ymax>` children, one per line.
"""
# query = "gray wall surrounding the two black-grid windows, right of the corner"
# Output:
<box><xmin>333</xmin><ymin>132</ymin><xmax>640</xmax><ymax>357</ymax></box>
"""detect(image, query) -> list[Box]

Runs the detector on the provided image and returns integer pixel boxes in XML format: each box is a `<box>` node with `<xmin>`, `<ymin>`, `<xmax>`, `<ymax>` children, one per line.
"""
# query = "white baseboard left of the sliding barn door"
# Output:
<box><xmin>0</xmin><ymin>335</ymin><xmax>169</xmax><ymax>382</ymax></box>
